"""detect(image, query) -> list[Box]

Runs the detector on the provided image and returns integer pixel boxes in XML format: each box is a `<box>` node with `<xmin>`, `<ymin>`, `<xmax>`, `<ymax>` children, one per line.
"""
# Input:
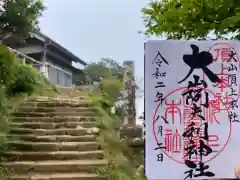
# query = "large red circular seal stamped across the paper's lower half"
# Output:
<box><xmin>152</xmin><ymin>87</ymin><xmax>232</xmax><ymax>164</ymax></box>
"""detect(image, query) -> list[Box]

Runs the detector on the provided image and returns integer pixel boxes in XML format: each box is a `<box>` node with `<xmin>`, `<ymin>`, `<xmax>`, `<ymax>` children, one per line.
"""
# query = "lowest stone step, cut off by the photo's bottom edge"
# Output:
<box><xmin>11</xmin><ymin>173</ymin><xmax>106</xmax><ymax>180</ymax></box>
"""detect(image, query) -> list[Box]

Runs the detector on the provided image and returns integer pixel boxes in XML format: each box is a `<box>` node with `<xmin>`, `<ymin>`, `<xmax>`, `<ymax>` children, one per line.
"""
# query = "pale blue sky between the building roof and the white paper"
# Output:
<box><xmin>40</xmin><ymin>0</ymin><xmax>149</xmax><ymax>123</ymax></box>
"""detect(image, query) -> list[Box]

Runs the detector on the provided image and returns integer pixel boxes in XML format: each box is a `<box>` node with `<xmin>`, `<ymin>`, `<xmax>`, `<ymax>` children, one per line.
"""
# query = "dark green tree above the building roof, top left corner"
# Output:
<box><xmin>0</xmin><ymin>0</ymin><xmax>44</xmax><ymax>42</ymax></box>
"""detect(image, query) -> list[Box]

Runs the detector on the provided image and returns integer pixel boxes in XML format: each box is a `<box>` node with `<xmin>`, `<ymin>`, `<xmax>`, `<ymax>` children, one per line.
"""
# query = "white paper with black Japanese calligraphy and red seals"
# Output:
<box><xmin>145</xmin><ymin>40</ymin><xmax>240</xmax><ymax>180</ymax></box>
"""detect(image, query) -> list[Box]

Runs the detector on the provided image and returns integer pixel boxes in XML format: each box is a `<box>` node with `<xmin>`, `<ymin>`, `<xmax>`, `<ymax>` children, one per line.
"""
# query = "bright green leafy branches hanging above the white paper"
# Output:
<box><xmin>142</xmin><ymin>0</ymin><xmax>240</xmax><ymax>39</ymax></box>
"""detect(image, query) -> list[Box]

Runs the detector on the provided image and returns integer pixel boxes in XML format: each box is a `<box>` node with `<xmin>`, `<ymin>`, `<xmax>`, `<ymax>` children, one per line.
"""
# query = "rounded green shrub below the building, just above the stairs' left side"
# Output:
<box><xmin>7</xmin><ymin>63</ymin><xmax>43</xmax><ymax>95</ymax></box>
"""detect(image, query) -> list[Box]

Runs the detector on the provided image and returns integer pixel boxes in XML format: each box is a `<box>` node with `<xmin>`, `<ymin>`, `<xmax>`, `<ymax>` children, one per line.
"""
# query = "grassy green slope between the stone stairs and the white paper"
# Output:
<box><xmin>87</xmin><ymin>94</ymin><xmax>146</xmax><ymax>180</ymax></box>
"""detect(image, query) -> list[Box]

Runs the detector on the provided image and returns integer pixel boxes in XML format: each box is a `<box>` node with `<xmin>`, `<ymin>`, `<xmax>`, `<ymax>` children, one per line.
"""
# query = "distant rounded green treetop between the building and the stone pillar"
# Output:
<box><xmin>84</xmin><ymin>58</ymin><xmax>122</xmax><ymax>82</ymax></box>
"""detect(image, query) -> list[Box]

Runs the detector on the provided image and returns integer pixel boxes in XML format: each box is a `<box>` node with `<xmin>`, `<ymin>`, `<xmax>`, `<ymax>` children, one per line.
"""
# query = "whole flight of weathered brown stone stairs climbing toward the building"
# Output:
<box><xmin>1</xmin><ymin>97</ymin><xmax>107</xmax><ymax>180</ymax></box>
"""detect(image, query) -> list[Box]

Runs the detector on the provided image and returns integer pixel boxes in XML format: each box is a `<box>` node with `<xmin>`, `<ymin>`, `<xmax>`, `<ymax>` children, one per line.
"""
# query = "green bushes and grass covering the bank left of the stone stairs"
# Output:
<box><xmin>0</xmin><ymin>41</ymin><xmax>56</xmax><ymax>180</ymax></box>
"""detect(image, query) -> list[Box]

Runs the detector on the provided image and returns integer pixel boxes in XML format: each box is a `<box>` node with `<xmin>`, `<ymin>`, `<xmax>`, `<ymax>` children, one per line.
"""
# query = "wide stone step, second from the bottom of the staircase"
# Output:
<box><xmin>0</xmin><ymin>160</ymin><xmax>107</xmax><ymax>174</ymax></box>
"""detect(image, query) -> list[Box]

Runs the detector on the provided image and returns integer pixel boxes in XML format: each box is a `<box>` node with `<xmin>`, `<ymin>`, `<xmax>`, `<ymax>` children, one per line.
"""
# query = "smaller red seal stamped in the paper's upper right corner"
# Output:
<box><xmin>206</xmin><ymin>43</ymin><xmax>240</xmax><ymax>109</ymax></box>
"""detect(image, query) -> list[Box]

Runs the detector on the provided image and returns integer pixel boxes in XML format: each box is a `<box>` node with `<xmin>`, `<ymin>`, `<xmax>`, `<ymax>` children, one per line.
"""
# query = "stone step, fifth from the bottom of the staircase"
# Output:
<box><xmin>9</xmin><ymin>134</ymin><xmax>96</xmax><ymax>142</ymax></box>
